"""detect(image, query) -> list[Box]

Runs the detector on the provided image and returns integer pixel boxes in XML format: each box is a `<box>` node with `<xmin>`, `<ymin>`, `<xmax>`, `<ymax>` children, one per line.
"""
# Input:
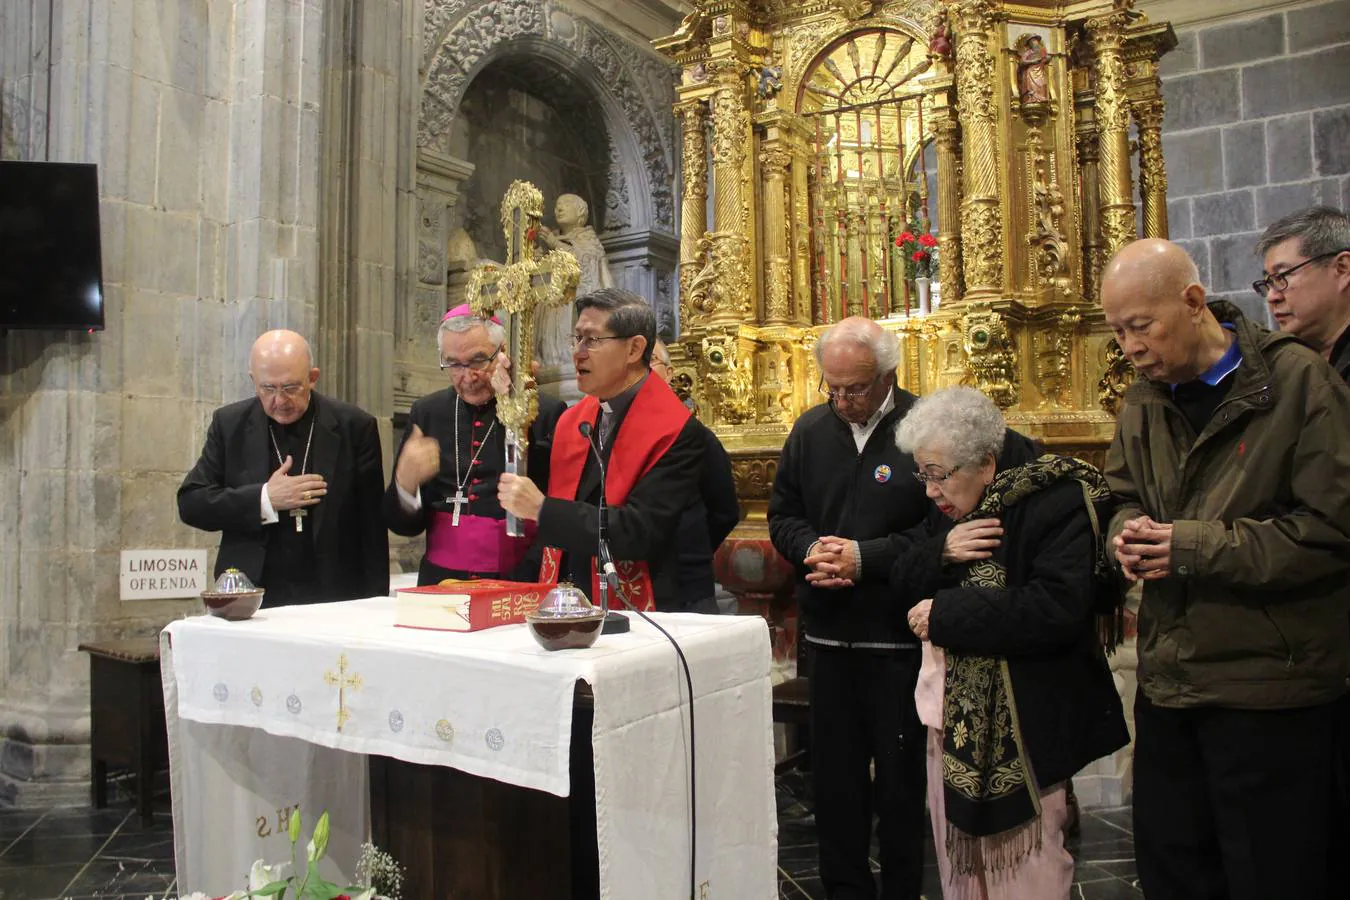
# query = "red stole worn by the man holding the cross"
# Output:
<box><xmin>539</xmin><ymin>374</ymin><xmax>690</xmax><ymax>611</ymax></box>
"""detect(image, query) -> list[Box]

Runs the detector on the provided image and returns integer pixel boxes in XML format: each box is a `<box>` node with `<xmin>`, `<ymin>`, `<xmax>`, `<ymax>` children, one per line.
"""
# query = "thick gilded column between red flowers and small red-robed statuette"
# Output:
<box><xmin>944</xmin><ymin>0</ymin><xmax>1003</xmax><ymax>300</ymax></box>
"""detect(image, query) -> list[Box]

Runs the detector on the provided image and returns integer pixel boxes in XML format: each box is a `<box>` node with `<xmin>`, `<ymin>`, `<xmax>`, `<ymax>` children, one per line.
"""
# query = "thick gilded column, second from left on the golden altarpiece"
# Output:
<box><xmin>709</xmin><ymin>59</ymin><xmax>753</xmax><ymax>324</ymax></box>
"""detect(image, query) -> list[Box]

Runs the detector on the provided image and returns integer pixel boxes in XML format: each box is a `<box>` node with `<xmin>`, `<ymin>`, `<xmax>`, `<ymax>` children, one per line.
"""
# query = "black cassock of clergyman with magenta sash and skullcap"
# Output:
<box><xmin>383</xmin><ymin>387</ymin><xmax>567</xmax><ymax>584</ymax></box>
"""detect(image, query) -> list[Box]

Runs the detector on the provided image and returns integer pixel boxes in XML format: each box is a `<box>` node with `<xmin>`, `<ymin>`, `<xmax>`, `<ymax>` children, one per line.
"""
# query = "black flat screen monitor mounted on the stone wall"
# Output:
<box><xmin>0</xmin><ymin>161</ymin><xmax>103</xmax><ymax>331</ymax></box>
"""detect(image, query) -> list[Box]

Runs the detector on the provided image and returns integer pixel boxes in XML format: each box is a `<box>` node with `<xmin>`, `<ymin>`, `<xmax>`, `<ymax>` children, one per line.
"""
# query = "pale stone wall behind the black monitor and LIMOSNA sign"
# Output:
<box><xmin>0</xmin><ymin>0</ymin><xmax>405</xmax><ymax>806</ymax></box>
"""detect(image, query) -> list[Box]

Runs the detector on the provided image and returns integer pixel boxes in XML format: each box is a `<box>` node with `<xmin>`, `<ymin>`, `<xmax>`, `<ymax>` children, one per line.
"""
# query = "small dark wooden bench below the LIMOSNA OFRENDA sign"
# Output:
<box><xmin>80</xmin><ymin>638</ymin><xmax>169</xmax><ymax>826</ymax></box>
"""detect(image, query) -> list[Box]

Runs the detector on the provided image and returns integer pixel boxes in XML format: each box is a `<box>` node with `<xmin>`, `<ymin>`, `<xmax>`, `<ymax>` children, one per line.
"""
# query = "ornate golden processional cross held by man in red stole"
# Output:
<box><xmin>455</xmin><ymin>181</ymin><xmax>582</xmax><ymax>537</ymax></box>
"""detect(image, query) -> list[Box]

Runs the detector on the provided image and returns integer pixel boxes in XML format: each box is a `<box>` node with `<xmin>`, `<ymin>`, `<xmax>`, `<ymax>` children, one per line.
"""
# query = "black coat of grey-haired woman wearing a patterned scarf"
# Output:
<box><xmin>895</xmin><ymin>432</ymin><xmax>1130</xmax><ymax>787</ymax></box>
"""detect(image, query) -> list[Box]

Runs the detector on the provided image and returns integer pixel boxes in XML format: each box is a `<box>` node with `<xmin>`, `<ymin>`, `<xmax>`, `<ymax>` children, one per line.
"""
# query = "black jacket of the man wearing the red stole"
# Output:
<box><xmin>539</xmin><ymin>416</ymin><xmax>706</xmax><ymax>613</ymax></box>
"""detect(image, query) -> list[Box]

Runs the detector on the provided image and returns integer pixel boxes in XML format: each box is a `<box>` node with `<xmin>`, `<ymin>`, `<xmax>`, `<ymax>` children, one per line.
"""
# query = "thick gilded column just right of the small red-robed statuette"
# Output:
<box><xmin>1088</xmin><ymin>12</ymin><xmax>1138</xmax><ymax>259</ymax></box>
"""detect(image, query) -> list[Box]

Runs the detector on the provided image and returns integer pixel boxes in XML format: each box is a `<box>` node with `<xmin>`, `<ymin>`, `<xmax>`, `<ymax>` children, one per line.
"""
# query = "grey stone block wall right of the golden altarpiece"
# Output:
<box><xmin>1162</xmin><ymin>0</ymin><xmax>1350</xmax><ymax>321</ymax></box>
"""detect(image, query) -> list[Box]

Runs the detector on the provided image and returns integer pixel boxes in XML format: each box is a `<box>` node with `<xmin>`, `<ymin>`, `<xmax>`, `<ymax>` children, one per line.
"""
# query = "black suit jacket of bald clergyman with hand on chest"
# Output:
<box><xmin>178</xmin><ymin>393</ymin><xmax>389</xmax><ymax>600</ymax></box>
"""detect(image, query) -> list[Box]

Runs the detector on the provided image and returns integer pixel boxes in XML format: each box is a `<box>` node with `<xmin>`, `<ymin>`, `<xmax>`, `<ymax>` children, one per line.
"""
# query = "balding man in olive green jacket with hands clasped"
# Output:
<box><xmin>1102</xmin><ymin>240</ymin><xmax>1350</xmax><ymax>900</ymax></box>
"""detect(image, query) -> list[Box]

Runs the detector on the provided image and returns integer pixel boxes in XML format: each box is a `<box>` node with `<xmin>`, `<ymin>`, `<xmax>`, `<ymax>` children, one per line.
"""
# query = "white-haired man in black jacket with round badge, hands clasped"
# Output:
<box><xmin>768</xmin><ymin>317</ymin><xmax>927</xmax><ymax>900</ymax></box>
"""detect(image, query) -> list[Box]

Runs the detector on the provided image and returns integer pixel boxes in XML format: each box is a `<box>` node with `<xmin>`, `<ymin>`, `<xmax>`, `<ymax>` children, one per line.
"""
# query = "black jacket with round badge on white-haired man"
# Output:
<box><xmin>768</xmin><ymin>389</ymin><xmax>932</xmax><ymax>650</ymax></box>
